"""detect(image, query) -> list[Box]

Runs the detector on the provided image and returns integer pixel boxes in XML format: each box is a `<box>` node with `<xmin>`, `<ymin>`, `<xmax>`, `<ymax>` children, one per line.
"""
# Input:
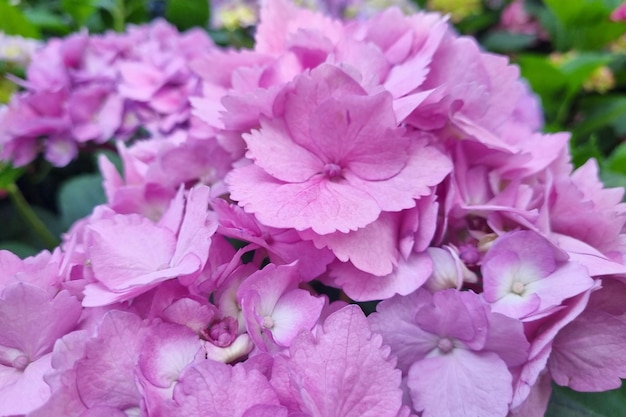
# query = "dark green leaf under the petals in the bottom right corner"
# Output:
<box><xmin>545</xmin><ymin>384</ymin><xmax>626</xmax><ymax>417</ymax></box>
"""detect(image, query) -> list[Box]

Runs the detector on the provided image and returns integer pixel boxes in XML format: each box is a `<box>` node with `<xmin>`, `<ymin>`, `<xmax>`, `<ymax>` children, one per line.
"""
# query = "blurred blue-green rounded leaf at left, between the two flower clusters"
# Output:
<box><xmin>59</xmin><ymin>174</ymin><xmax>106</xmax><ymax>228</ymax></box>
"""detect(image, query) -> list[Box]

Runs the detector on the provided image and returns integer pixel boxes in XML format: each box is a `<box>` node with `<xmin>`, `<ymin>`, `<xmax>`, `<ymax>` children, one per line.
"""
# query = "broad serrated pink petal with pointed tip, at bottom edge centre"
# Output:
<box><xmin>271</xmin><ymin>306</ymin><xmax>402</xmax><ymax>417</ymax></box>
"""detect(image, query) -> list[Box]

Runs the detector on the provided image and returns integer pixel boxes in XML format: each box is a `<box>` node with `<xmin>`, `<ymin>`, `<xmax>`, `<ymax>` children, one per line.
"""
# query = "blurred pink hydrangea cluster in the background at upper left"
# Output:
<box><xmin>0</xmin><ymin>21</ymin><xmax>213</xmax><ymax>166</ymax></box>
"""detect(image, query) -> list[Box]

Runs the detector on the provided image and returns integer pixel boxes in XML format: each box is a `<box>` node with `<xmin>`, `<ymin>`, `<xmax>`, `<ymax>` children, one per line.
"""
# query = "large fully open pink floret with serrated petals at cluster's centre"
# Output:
<box><xmin>227</xmin><ymin>65</ymin><xmax>451</xmax><ymax>235</ymax></box>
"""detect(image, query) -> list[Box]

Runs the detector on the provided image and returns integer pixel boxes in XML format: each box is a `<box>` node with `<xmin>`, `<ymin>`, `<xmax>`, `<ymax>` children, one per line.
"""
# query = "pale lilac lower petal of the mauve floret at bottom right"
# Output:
<box><xmin>407</xmin><ymin>349</ymin><xmax>513</xmax><ymax>417</ymax></box>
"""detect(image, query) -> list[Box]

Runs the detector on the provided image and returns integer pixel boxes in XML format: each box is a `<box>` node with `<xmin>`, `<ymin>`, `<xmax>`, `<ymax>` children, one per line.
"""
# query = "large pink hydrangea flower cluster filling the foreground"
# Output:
<box><xmin>0</xmin><ymin>0</ymin><xmax>626</xmax><ymax>417</ymax></box>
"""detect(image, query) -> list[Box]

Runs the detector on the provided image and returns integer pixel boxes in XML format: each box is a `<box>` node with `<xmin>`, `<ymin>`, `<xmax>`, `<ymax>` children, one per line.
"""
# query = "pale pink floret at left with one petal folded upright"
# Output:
<box><xmin>83</xmin><ymin>187</ymin><xmax>217</xmax><ymax>306</ymax></box>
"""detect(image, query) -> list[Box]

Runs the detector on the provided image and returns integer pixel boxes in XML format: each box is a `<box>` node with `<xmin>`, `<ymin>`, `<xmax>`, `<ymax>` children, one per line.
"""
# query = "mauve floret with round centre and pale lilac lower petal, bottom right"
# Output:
<box><xmin>369</xmin><ymin>289</ymin><xmax>528</xmax><ymax>417</ymax></box>
